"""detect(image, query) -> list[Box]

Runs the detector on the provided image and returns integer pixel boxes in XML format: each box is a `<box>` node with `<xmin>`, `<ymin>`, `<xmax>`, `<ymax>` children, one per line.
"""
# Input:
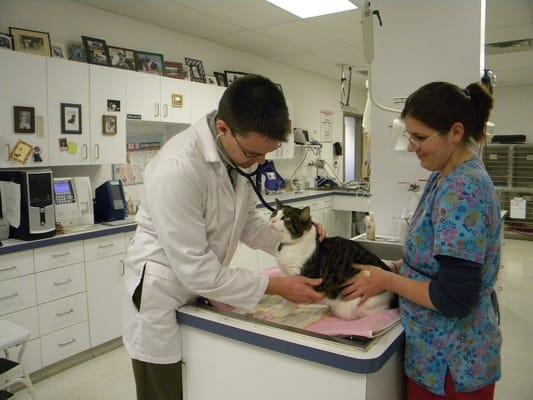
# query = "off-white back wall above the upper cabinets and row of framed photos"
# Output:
<box><xmin>0</xmin><ymin>0</ymin><xmax>365</xmax><ymax>195</ymax></box>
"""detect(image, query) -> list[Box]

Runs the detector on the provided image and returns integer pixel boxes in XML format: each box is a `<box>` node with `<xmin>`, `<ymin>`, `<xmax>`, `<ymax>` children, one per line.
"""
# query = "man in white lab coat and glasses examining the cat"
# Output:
<box><xmin>123</xmin><ymin>75</ymin><xmax>321</xmax><ymax>400</ymax></box>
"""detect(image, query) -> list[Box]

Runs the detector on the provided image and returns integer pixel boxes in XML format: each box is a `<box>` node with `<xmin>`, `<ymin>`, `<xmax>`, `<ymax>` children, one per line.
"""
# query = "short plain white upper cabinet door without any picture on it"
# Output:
<box><xmin>126</xmin><ymin>71</ymin><xmax>161</xmax><ymax>121</ymax></box>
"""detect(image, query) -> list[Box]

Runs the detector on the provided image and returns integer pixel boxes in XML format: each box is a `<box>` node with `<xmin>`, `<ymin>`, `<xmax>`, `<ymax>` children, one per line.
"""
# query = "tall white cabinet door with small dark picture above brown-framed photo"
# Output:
<box><xmin>89</xmin><ymin>65</ymin><xmax>126</xmax><ymax>164</ymax></box>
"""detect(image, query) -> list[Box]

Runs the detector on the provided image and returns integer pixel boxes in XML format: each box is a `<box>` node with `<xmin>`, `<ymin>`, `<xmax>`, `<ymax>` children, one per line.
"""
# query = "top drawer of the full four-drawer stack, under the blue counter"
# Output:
<box><xmin>34</xmin><ymin>240</ymin><xmax>83</xmax><ymax>272</ymax></box>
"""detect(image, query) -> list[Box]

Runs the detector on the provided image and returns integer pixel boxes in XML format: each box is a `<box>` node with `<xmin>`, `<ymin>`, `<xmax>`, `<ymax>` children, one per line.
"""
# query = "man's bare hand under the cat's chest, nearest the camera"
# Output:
<box><xmin>266</xmin><ymin>275</ymin><xmax>324</xmax><ymax>303</ymax></box>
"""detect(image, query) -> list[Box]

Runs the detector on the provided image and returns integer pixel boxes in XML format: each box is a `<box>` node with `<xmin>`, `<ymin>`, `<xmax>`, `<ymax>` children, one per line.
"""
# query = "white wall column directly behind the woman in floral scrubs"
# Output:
<box><xmin>371</xmin><ymin>0</ymin><xmax>484</xmax><ymax>234</ymax></box>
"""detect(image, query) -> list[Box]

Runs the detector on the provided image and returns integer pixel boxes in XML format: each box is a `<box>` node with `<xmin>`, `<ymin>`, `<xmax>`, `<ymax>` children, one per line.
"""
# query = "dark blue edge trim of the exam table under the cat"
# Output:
<box><xmin>177</xmin><ymin>311</ymin><xmax>404</xmax><ymax>374</ymax></box>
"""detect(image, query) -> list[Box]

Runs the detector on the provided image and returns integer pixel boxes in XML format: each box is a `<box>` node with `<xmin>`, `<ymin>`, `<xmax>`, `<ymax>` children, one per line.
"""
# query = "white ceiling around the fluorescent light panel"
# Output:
<box><xmin>73</xmin><ymin>0</ymin><xmax>533</xmax><ymax>86</ymax></box>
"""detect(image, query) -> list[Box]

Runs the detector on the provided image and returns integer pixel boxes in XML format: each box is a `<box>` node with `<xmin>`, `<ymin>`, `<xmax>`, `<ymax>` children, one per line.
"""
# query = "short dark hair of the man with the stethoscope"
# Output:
<box><xmin>217</xmin><ymin>75</ymin><xmax>289</xmax><ymax>141</ymax></box>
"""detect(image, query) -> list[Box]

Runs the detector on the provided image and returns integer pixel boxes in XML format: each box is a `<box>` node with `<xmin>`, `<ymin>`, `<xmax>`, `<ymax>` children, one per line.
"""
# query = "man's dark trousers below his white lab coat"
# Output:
<box><xmin>131</xmin><ymin>359</ymin><xmax>182</xmax><ymax>400</ymax></box>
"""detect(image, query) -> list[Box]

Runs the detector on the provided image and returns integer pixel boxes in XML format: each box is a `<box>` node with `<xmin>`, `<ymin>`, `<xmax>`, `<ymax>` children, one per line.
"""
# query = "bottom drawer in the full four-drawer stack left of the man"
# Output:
<box><xmin>41</xmin><ymin>322</ymin><xmax>89</xmax><ymax>367</ymax></box>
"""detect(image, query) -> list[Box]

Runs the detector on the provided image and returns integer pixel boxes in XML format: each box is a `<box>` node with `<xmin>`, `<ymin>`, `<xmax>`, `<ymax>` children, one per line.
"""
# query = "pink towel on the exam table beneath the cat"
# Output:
<box><xmin>305</xmin><ymin>308</ymin><xmax>400</xmax><ymax>338</ymax></box>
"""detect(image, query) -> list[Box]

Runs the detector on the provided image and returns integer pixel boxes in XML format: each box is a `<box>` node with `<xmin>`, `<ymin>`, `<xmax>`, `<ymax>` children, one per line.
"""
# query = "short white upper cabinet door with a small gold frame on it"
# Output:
<box><xmin>161</xmin><ymin>77</ymin><xmax>191</xmax><ymax>124</ymax></box>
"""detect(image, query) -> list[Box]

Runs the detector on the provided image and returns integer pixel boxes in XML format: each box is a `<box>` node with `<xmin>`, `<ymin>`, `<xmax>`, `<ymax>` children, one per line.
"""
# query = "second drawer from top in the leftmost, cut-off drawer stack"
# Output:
<box><xmin>0</xmin><ymin>275</ymin><xmax>37</xmax><ymax>315</ymax></box>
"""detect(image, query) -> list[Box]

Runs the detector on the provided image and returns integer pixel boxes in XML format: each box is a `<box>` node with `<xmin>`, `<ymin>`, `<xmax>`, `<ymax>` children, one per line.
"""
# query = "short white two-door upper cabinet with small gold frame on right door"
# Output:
<box><xmin>126</xmin><ymin>71</ymin><xmax>191</xmax><ymax>124</ymax></box>
